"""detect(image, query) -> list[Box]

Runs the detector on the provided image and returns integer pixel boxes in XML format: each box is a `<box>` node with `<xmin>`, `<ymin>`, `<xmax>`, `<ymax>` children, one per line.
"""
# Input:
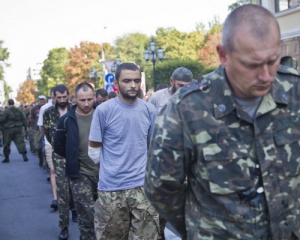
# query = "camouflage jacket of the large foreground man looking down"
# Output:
<box><xmin>145</xmin><ymin>66</ymin><xmax>300</xmax><ymax>240</ymax></box>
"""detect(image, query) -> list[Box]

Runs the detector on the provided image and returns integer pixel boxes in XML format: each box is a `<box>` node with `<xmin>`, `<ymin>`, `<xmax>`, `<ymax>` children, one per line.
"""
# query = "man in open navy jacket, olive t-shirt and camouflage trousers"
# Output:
<box><xmin>54</xmin><ymin>82</ymin><xmax>99</xmax><ymax>240</ymax></box>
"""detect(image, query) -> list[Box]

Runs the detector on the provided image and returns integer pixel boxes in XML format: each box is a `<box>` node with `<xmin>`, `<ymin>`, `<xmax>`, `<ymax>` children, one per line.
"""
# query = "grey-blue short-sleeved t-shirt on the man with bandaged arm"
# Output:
<box><xmin>89</xmin><ymin>97</ymin><xmax>157</xmax><ymax>191</ymax></box>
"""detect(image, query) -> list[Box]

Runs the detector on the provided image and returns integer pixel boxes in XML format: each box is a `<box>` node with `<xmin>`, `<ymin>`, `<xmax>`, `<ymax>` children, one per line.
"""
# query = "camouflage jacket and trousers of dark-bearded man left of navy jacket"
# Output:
<box><xmin>43</xmin><ymin>106</ymin><xmax>75</xmax><ymax>229</ymax></box>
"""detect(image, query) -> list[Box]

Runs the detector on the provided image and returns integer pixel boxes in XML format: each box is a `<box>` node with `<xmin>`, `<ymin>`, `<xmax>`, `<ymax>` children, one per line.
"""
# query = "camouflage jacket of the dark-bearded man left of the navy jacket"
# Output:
<box><xmin>43</xmin><ymin>105</ymin><xmax>71</xmax><ymax>146</ymax></box>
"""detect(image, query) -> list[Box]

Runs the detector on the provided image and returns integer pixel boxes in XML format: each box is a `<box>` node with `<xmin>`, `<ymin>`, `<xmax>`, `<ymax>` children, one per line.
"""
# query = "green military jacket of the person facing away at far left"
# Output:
<box><xmin>0</xmin><ymin>106</ymin><xmax>28</xmax><ymax>129</ymax></box>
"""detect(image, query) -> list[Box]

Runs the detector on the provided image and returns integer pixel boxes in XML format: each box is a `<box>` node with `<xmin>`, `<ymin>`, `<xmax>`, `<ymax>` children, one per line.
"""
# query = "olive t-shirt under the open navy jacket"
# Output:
<box><xmin>76</xmin><ymin>113</ymin><xmax>99</xmax><ymax>176</ymax></box>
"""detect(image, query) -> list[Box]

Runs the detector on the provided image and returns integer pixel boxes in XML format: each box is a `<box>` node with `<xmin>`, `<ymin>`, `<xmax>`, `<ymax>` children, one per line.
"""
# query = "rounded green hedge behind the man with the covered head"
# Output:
<box><xmin>145</xmin><ymin>59</ymin><xmax>211</xmax><ymax>89</ymax></box>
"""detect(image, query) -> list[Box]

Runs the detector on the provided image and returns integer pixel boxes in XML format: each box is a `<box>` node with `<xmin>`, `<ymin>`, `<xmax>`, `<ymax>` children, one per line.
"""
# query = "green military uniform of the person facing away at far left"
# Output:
<box><xmin>0</xmin><ymin>106</ymin><xmax>28</xmax><ymax>162</ymax></box>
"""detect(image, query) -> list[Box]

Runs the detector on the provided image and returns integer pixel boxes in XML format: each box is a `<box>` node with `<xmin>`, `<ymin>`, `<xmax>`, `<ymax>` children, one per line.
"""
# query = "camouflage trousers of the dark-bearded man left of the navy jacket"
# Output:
<box><xmin>53</xmin><ymin>153</ymin><xmax>75</xmax><ymax>229</ymax></box>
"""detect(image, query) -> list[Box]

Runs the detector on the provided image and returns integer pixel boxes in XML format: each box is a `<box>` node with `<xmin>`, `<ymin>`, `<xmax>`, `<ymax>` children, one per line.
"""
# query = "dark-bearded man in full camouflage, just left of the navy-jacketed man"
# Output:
<box><xmin>43</xmin><ymin>84</ymin><xmax>78</xmax><ymax>240</ymax></box>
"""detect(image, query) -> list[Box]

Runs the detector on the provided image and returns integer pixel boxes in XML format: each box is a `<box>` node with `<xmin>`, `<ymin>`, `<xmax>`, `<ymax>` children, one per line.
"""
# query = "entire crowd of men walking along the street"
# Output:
<box><xmin>0</xmin><ymin>4</ymin><xmax>300</xmax><ymax>240</ymax></box>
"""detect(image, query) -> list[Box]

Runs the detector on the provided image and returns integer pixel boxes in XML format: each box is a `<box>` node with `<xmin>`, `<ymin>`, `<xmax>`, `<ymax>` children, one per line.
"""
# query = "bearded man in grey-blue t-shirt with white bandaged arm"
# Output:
<box><xmin>89</xmin><ymin>63</ymin><xmax>159</xmax><ymax>239</ymax></box>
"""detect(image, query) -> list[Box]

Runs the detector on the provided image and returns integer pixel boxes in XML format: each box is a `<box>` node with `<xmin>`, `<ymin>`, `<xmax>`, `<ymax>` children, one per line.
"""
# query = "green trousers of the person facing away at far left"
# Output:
<box><xmin>3</xmin><ymin>127</ymin><xmax>27</xmax><ymax>156</ymax></box>
